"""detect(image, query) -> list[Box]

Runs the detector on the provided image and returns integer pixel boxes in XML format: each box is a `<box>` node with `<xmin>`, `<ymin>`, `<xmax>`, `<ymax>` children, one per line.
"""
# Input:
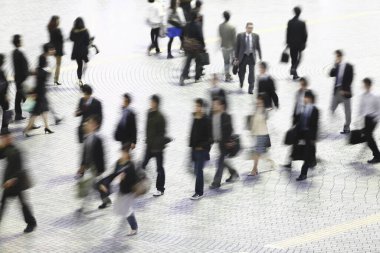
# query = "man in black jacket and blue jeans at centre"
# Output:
<box><xmin>189</xmin><ymin>98</ymin><xmax>212</xmax><ymax>200</ymax></box>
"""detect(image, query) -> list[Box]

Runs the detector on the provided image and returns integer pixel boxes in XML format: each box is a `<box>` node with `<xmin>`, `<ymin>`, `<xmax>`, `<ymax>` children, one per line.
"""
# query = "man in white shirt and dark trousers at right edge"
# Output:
<box><xmin>359</xmin><ymin>78</ymin><xmax>380</xmax><ymax>164</ymax></box>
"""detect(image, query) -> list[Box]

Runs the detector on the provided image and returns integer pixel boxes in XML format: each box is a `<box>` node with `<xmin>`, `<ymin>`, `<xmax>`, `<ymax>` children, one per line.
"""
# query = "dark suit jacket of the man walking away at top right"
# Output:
<box><xmin>286</xmin><ymin>17</ymin><xmax>307</xmax><ymax>51</ymax></box>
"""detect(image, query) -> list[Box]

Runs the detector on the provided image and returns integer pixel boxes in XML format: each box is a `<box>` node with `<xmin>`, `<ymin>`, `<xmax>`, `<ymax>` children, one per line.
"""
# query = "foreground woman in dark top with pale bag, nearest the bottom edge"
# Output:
<box><xmin>114</xmin><ymin>143</ymin><xmax>139</xmax><ymax>236</ymax></box>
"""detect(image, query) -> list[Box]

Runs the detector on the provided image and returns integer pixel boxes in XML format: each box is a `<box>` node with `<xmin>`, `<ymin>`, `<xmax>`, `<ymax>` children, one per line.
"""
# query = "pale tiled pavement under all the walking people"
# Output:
<box><xmin>0</xmin><ymin>0</ymin><xmax>380</xmax><ymax>253</ymax></box>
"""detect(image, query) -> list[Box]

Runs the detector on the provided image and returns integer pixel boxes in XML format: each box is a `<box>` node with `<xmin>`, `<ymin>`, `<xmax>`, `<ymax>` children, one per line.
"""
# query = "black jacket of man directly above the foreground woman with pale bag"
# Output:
<box><xmin>114</xmin><ymin>109</ymin><xmax>137</xmax><ymax>144</ymax></box>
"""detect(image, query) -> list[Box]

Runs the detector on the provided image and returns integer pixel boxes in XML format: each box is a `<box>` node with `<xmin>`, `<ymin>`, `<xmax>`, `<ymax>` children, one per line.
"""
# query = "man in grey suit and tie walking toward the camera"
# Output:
<box><xmin>235</xmin><ymin>22</ymin><xmax>262</xmax><ymax>94</ymax></box>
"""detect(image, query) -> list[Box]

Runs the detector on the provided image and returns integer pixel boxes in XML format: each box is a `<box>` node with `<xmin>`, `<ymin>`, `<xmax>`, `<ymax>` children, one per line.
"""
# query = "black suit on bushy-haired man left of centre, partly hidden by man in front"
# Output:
<box><xmin>76</xmin><ymin>97</ymin><xmax>103</xmax><ymax>143</ymax></box>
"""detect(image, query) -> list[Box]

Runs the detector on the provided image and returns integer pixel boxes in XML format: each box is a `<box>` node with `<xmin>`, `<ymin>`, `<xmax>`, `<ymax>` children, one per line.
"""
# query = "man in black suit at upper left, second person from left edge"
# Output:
<box><xmin>12</xmin><ymin>34</ymin><xmax>29</xmax><ymax>120</ymax></box>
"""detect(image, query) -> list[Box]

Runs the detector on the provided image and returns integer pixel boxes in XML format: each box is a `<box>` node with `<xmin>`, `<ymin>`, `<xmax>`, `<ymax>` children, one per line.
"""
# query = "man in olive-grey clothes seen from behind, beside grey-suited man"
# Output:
<box><xmin>219</xmin><ymin>11</ymin><xmax>236</xmax><ymax>82</ymax></box>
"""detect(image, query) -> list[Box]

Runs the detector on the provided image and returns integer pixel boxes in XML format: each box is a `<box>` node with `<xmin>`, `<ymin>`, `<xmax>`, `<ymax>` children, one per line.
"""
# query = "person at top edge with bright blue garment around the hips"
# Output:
<box><xmin>167</xmin><ymin>0</ymin><xmax>186</xmax><ymax>59</ymax></box>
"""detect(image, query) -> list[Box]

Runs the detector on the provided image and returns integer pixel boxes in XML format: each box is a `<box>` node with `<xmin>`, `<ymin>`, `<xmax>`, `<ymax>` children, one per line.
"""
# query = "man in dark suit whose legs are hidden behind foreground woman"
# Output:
<box><xmin>114</xmin><ymin>93</ymin><xmax>137</xmax><ymax>149</ymax></box>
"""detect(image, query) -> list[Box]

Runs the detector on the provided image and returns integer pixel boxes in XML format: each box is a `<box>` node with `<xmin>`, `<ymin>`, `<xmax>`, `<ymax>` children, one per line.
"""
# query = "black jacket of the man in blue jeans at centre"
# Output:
<box><xmin>189</xmin><ymin>115</ymin><xmax>212</xmax><ymax>150</ymax></box>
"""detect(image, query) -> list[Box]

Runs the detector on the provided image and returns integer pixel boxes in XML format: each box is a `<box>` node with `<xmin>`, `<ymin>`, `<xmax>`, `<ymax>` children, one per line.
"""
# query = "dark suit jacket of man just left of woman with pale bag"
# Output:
<box><xmin>81</xmin><ymin>134</ymin><xmax>105</xmax><ymax>175</ymax></box>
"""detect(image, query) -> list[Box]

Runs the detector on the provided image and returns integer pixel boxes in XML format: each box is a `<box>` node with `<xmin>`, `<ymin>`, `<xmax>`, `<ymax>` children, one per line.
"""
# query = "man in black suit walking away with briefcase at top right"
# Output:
<box><xmin>286</xmin><ymin>7</ymin><xmax>307</xmax><ymax>80</ymax></box>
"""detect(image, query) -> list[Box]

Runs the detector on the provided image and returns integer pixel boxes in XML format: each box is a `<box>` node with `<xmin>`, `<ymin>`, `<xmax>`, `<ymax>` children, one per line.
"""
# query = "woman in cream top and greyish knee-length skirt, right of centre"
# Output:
<box><xmin>248</xmin><ymin>95</ymin><xmax>271</xmax><ymax>176</ymax></box>
